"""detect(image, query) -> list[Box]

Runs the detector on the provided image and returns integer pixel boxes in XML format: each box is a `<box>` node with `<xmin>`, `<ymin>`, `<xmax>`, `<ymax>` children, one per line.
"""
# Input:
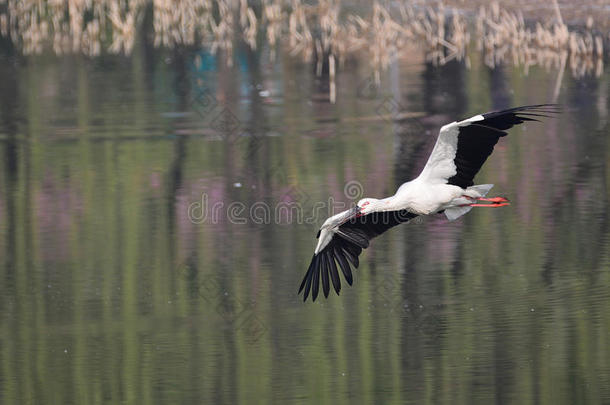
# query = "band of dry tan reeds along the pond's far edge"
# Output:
<box><xmin>0</xmin><ymin>0</ymin><xmax>604</xmax><ymax>76</ymax></box>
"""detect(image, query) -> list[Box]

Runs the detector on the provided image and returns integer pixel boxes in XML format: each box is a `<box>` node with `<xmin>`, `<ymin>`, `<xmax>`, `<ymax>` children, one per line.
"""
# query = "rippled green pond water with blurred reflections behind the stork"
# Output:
<box><xmin>0</xmin><ymin>42</ymin><xmax>610</xmax><ymax>404</ymax></box>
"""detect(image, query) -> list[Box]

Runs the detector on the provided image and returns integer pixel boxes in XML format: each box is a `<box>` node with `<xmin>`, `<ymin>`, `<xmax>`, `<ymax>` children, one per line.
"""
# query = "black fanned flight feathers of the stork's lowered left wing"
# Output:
<box><xmin>299</xmin><ymin>210</ymin><xmax>417</xmax><ymax>301</ymax></box>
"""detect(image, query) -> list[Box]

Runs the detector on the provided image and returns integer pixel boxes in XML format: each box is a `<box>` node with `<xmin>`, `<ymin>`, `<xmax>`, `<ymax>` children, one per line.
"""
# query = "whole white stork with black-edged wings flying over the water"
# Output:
<box><xmin>299</xmin><ymin>104</ymin><xmax>560</xmax><ymax>301</ymax></box>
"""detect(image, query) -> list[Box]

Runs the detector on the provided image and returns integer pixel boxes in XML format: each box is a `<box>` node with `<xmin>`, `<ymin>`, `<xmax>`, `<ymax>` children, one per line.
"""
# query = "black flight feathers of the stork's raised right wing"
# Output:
<box><xmin>447</xmin><ymin>104</ymin><xmax>560</xmax><ymax>188</ymax></box>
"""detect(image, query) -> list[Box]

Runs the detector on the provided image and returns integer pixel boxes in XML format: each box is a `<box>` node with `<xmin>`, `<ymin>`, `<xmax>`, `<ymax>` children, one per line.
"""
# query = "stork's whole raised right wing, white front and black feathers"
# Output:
<box><xmin>419</xmin><ymin>104</ymin><xmax>560</xmax><ymax>188</ymax></box>
